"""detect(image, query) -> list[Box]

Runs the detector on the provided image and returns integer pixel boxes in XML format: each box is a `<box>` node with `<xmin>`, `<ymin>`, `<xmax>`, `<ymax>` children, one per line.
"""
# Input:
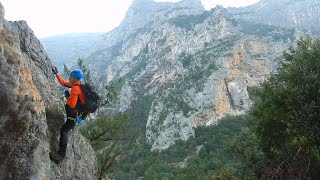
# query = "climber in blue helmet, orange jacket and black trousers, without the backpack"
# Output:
<box><xmin>50</xmin><ymin>67</ymin><xmax>87</xmax><ymax>164</ymax></box>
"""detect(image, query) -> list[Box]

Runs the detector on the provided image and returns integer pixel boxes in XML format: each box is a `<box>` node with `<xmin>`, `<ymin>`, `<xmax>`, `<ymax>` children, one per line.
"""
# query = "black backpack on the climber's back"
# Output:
<box><xmin>77</xmin><ymin>83</ymin><xmax>100</xmax><ymax>113</ymax></box>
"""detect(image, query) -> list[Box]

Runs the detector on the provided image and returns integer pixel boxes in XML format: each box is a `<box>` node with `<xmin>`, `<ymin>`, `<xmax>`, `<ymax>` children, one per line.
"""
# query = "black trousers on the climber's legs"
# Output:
<box><xmin>58</xmin><ymin>104</ymin><xmax>77</xmax><ymax>156</ymax></box>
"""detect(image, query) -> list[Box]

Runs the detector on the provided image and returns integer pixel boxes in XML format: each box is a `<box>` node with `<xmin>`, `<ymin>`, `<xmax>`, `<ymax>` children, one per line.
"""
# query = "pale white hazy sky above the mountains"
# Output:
<box><xmin>0</xmin><ymin>0</ymin><xmax>259</xmax><ymax>38</ymax></box>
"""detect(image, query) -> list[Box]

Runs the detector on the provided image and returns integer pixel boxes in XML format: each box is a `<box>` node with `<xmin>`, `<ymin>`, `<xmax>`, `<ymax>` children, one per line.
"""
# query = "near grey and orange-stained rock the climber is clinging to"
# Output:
<box><xmin>0</xmin><ymin>4</ymin><xmax>97</xmax><ymax>179</ymax></box>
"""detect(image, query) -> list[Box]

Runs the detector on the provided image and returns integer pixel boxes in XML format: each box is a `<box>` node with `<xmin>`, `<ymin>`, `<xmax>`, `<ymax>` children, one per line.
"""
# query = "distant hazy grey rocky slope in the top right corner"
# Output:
<box><xmin>232</xmin><ymin>0</ymin><xmax>320</xmax><ymax>34</ymax></box>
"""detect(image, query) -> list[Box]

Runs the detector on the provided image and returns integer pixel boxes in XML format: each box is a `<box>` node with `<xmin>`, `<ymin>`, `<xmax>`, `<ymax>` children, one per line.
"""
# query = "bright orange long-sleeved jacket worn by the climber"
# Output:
<box><xmin>56</xmin><ymin>74</ymin><xmax>86</xmax><ymax>109</ymax></box>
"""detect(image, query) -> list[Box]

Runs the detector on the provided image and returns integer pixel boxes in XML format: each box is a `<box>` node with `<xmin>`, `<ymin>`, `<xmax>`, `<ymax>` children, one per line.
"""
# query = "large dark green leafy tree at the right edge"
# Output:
<box><xmin>248</xmin><ymin>37</ymin><xmax>320</xmax><ymax>179</ymax></box>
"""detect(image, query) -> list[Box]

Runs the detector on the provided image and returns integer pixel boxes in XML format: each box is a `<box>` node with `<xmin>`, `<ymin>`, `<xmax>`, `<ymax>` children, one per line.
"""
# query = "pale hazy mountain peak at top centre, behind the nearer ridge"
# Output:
<box><xmin>104</xmin><ymin>0</ymin><xmax>205</xmax><ymax>51</ymax></box>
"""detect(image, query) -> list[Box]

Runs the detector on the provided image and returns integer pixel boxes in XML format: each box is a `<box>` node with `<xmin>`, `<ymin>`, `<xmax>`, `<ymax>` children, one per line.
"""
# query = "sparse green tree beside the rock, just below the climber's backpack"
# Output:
<box><xmin>80</xmin><ymin>113</ymin><xmax>138</xmax><ymax>179</ymax></box>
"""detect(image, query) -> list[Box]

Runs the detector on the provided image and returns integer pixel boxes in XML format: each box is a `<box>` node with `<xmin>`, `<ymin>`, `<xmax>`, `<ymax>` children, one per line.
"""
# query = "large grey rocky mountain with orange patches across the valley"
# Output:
<box><xmin>42</xmin><ymin>0</ymin><xmax>320</xmax><ymax>150</ymax></box>
